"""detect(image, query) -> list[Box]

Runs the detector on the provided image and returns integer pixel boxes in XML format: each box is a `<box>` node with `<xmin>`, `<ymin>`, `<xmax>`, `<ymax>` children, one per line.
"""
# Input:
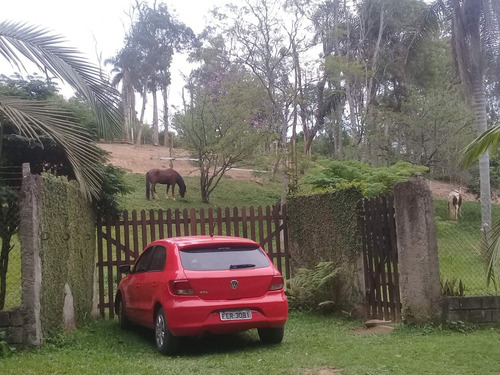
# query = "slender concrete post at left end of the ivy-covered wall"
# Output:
<box><xmin>19</xmin><ymin>164</ymin><xmax>43</xmax><ymax>346</ymax></box>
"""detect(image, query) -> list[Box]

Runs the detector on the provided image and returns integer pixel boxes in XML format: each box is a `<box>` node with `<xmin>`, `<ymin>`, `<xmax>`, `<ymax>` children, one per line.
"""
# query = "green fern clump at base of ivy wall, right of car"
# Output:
<box><xmin>287</xmin><ymin>262</ymin><xmax>339</xmax><ymax>311</ymax></box>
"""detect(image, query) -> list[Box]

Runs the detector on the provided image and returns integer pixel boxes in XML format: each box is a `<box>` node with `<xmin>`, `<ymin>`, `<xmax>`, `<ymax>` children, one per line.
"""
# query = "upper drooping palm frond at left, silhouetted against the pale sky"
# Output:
<box><xmin>0</xmin><ymin>21</ymin><xmax>122</xmax><ymax>139</ymax></box>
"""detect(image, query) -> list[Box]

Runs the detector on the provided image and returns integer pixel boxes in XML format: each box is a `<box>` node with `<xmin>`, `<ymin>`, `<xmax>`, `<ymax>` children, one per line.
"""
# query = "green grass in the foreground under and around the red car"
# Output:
<box><xmin>0</xmin><ymin>313</ymin><xmax>500</xmax><ymax>375</ymax></box>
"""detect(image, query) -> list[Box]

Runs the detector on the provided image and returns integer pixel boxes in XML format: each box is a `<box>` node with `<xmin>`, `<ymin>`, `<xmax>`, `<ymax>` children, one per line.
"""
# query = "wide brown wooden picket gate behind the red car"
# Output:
<box><xmin>97</xmin><ymin>204</ymin><xmax>290</xmax><ymax>318</ymax></box>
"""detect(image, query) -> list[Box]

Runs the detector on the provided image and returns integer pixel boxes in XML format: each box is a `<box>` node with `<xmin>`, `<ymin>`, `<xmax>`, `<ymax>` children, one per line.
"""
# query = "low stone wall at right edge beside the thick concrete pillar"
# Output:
<box><xmin>442</xmin><ymin>296</ymin><xmax>500</xmax><ymax>323</ymax></box>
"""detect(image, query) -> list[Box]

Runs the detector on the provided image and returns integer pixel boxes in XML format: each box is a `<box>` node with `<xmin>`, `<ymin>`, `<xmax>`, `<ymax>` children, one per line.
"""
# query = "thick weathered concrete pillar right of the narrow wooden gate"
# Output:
<box><xmin>394</xmin><ymin>177</ymin><xmax>441</xmax><ymax>323</ymax></box>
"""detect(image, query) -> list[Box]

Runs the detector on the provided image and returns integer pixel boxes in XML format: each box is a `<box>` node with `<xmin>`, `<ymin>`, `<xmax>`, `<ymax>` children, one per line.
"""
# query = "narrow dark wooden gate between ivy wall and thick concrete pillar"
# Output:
<box><xmin>358</xmin><ymin>196</ymin><xmax>401</xmax><ymax>322</ymax></box>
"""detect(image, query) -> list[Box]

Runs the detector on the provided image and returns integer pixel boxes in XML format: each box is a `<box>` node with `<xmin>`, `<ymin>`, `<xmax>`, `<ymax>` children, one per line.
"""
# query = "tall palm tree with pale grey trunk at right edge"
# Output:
<box><xmin>431</xmin><ymin>0</ymin><xmax>500</xmax><ymax>228</ymax></box>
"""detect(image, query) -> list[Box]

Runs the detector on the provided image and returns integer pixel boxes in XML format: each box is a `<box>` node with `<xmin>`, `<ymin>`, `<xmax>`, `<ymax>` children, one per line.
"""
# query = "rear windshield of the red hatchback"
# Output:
<box><xmin>180</xmin><ymin>247</ymin><xmax>269</xmax><ymax>271</ymax></box>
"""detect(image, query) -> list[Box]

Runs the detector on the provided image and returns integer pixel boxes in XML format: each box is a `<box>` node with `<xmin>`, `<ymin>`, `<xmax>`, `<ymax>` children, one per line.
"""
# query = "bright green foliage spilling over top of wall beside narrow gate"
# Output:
<box><xmin>305</xmin><ymin>160</ymin><xmax>428</xmax><ymax>198</ymax></box>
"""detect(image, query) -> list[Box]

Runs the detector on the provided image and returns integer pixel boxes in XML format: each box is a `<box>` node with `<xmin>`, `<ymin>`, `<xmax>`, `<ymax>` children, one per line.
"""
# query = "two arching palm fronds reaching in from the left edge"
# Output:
<box><xmin>0</xmin><ymin>21</ymin><xmax>122</xmax><ymax>198</ymax></box>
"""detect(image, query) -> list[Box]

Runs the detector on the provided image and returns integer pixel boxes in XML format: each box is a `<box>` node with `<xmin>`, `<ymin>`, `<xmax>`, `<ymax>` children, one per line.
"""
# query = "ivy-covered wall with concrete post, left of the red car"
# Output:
<box><xmin>0</xmin><ymin>164</ymin><xmax>95</xmax><ymax>346</ymax></box>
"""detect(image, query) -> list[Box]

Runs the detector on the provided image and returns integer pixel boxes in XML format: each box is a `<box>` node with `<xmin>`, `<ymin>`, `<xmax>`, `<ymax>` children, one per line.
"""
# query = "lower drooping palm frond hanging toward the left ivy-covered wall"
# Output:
<box><xmin>0</xmin><ymin>96</ymin><xmax>101</xmax><ymax>198</ymax></box>
